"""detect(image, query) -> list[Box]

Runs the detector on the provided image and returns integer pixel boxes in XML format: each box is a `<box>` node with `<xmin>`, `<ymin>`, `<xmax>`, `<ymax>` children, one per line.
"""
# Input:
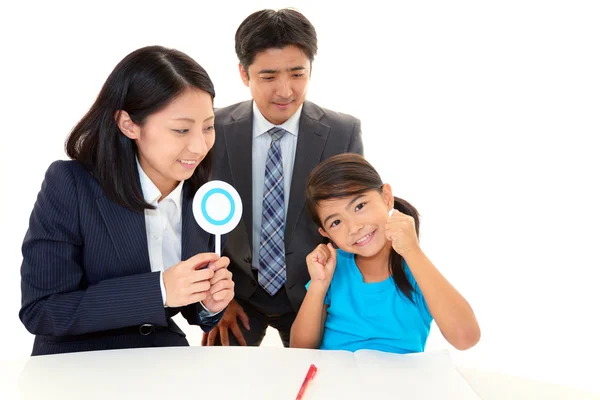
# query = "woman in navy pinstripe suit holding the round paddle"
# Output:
<box><xmin>19</xmin><ymin>46</ymin><xmax>233</xmax><ymax>355</ymax></box>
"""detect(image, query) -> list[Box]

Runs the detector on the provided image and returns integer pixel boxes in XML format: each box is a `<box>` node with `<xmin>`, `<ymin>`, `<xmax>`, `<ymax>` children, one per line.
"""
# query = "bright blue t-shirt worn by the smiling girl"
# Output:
<box><xmin>306</xmin><ymin>250</ymin><xmax>433</xmax><ymax>353</ymax></box>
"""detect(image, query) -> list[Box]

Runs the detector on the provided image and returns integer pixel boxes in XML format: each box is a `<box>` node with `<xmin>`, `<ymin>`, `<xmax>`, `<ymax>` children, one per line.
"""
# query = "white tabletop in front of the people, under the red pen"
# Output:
<box><xmin>0</xmin><ymin>346</ymin><xmax>600</xmax><ymax>400</ymax></box>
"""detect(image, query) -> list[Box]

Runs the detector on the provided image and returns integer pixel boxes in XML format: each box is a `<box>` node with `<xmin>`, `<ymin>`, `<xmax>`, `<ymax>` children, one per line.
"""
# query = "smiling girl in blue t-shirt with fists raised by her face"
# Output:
<box><xmin>291</xmin><ymin>154</ymin><xmax>480</xmax><ymax>353</ymax></box>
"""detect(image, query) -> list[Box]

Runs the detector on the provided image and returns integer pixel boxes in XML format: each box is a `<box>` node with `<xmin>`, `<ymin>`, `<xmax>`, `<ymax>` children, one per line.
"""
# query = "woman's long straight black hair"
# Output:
<box><xmin>65</xmin><ymin>46</ymin><xmax>215</xmax><ymax>212</ymax></box>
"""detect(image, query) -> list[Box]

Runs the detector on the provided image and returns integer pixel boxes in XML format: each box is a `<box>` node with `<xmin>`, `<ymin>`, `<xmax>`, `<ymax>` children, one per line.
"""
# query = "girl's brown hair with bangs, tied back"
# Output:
<box><xmin>305</xmin><ymin>153</ymin><xmax>419</xmax><ymax>301</ymax></box>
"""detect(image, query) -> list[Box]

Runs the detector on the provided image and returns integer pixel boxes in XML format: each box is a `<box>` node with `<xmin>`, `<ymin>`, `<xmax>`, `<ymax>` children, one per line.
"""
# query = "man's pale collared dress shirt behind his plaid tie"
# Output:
<box><xmin>252</xmin><ymin>102</ymin><xmax>302</xmax><ymax>269</ymax></box>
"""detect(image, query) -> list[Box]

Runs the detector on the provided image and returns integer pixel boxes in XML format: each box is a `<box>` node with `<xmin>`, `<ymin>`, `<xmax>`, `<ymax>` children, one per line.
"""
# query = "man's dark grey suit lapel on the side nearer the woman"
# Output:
<box><xmin>223</xmin><ymin>101</ymin><xmax>252</xmax><ymax>250</ymax></box>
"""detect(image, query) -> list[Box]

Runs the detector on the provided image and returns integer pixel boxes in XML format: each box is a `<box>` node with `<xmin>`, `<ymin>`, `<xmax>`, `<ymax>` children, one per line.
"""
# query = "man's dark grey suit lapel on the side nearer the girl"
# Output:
<box><xmin>285</xmin><ymin>101</ymin><xmax>329</xmax><ymax>248</ymax></box>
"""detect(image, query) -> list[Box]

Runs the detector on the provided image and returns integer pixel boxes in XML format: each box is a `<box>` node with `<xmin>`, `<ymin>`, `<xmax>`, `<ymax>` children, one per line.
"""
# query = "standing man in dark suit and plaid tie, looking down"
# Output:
<box><xmin>203</xmin><ymin>9</ymin><xmax>363</xmax><ymax>346</ymax></box>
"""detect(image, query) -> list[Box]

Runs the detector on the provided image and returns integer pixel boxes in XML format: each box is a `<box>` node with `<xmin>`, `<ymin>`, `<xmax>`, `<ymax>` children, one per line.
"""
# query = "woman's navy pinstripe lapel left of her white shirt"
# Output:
<box><xmin>96</xmin><ymin>195</ymin><xmax>150</xmax><ymax>274</ymax></box>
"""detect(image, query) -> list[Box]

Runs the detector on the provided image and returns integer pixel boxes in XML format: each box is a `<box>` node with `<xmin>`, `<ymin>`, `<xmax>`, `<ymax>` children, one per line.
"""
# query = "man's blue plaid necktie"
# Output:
<box><xmin>258</xmin><ymin>127</ymin><xmax>286</xmax><ymax>296</ymax></box>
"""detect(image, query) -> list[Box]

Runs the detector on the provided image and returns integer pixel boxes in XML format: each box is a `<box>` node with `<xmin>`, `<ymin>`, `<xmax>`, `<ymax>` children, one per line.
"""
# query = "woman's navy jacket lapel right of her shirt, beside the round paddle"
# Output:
<box><xmin>181</xmin><ymin>183</ymin><xmax>215</xmax><ymax>261</ymax></box>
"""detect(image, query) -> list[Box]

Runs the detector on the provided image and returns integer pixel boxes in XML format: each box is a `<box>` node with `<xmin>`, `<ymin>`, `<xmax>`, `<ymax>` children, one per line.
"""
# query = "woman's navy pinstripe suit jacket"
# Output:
<box><xmin>19</xmin><ymin>161</ymin><xmax>222</xmax><ymax>355</ymax></box>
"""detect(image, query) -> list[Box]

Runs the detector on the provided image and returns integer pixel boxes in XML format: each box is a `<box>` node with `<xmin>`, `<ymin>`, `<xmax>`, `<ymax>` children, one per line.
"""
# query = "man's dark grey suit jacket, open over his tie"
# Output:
<box><xmin>213</xmin><ymin>101</ymin><xmax>363</xmax><ymax>311</ymax></box>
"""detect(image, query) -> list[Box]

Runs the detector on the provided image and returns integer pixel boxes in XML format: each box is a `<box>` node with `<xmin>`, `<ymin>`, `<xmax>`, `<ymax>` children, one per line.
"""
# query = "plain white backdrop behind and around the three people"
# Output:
<box><xmin>0</xmin><ymin>0</ymin><xmax>600</xmax><ymax>391</ymax></box>
